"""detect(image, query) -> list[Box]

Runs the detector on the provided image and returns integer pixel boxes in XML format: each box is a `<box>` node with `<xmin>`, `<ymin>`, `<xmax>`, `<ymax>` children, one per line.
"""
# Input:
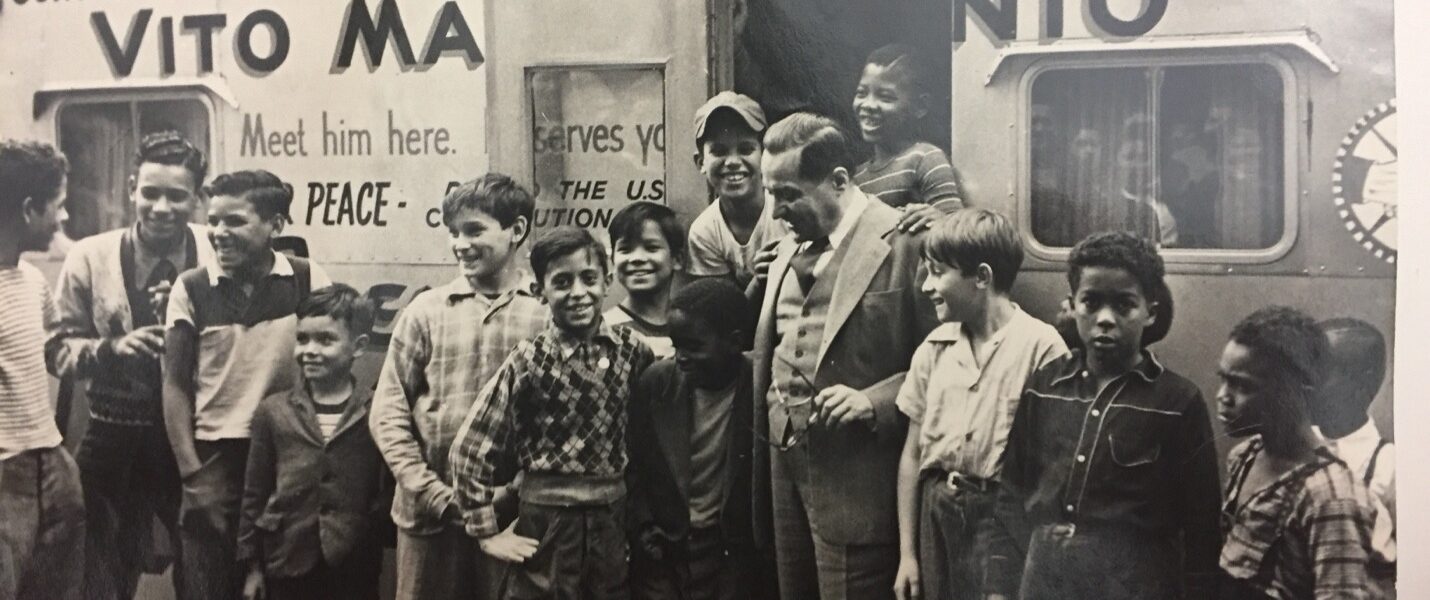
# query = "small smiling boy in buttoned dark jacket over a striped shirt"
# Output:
<box><xmin>239</xmin><ymin>284</ymin><xmax>385</xmax><ymax>600</ymax></box>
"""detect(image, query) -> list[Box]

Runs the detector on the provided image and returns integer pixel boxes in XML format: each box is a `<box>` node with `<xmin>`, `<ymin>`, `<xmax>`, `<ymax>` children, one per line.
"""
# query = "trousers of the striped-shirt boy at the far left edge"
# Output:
<box><xmin>0</xmin><ymin>447</ymin><xmax>84</xmax><ymax>600</ymax></box>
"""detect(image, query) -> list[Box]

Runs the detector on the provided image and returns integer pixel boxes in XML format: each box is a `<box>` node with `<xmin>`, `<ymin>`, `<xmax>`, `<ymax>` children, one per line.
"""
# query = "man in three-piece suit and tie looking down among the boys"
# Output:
<box><xmin>754</xmin><ymin>113</ymin><xmax>937</xmax><ymax>600</ymax></box>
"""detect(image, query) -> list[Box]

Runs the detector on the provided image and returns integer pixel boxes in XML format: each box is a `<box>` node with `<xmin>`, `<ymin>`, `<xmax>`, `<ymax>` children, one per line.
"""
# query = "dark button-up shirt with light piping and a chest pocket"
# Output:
<box><xmin>988</xmin><ymin>350</ymin><xmax>1221</xmax><ymax>597</ymax></box>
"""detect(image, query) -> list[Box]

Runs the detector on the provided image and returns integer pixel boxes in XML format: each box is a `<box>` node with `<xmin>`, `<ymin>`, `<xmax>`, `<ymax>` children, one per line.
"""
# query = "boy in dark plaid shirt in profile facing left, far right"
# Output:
<box><xmin>1217</xmin><ymin>306</ymin><xmax>1376</xmax><ymax>600</ymax></box>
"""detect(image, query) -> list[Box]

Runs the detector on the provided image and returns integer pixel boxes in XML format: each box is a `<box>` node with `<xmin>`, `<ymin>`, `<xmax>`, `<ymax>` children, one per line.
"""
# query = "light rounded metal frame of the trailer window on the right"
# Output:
<box><xmin>1014</xmin><ymin>51</ymin><xmax>1304</xmax><ymax>264</ymax></box>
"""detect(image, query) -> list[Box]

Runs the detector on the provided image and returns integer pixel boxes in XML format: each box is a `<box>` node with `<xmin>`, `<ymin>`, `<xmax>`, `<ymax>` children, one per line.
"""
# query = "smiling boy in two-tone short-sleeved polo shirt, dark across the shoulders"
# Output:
<box><xmin>163</xmin><ymin>170</ymin><xmax>332</xmax><ymax>599</ymax></box>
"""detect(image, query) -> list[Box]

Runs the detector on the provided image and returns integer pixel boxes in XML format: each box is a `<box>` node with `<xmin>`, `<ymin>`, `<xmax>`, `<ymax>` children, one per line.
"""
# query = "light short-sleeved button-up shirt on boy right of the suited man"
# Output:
<box><xmin>897</xmin><ymin>307</ymin><xmax>1068</xmax><ymax>479</ymax></box>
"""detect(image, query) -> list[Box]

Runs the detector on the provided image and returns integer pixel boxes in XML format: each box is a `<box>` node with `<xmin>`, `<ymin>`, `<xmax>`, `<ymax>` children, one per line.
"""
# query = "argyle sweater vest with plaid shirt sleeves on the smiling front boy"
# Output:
<box><xmin>452</xmin><ymin>323</ymin><xmax>655</xmax><ymax>537</ymax></box>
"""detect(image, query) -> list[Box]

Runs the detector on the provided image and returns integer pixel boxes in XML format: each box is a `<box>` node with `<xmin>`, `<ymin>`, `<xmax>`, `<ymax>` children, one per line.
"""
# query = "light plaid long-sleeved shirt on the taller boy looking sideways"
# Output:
<box><xmin>370</xmin><ymin>277</ymin><xmax>551</xmax><ymax>534</ymax></box>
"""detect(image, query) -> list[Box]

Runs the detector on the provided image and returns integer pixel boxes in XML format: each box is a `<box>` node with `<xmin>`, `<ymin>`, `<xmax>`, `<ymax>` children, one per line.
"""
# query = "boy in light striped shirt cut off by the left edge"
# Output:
<box><xmin>0</xmin><ymin>141</ymin><xmax>84</xmax><ymax>600</ymax></box>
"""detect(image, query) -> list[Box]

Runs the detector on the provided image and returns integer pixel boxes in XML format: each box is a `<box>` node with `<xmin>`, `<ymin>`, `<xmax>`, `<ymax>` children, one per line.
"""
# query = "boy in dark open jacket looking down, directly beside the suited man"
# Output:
<box><xmin>628</xmin><ymin>277</ymin><xmax>774</xmax><ymax>600</ymax></box>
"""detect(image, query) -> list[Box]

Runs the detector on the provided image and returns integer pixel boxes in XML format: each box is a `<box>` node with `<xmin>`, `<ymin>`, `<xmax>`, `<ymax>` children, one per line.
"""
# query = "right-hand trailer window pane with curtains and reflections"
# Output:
<box><xmin>1028</xmin><ymin>64</ymin><xmax>1286</xmax><ymax>250</ymax></box>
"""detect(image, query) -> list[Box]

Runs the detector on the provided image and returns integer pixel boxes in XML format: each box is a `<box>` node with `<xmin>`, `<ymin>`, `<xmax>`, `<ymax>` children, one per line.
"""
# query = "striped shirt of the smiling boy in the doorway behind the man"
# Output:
<box><xmin>854</xmin><ymin>141</ymin><xmax>962</xmax><ymax>210</ymax></box>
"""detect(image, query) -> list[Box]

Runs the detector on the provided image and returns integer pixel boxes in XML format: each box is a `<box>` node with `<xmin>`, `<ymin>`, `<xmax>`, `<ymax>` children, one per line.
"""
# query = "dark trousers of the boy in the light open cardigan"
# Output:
<box><xmin>76</xmin><ymin>419</ymin><xmax>183</xmax><ymax>600</ymax></box>
